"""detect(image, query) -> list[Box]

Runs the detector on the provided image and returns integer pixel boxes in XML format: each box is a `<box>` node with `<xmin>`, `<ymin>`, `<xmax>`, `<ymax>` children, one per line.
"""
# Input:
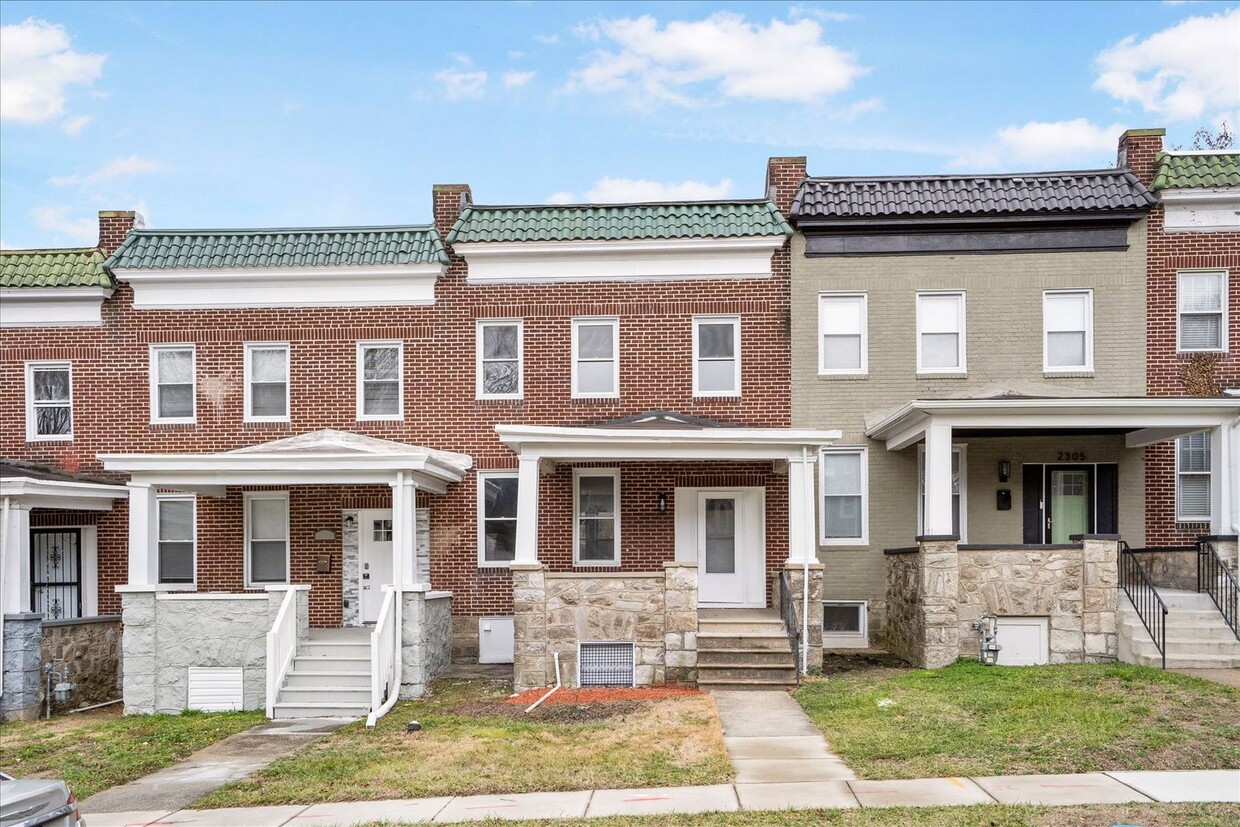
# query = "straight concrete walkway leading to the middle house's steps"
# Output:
<box><xmin>711</xmin><ymin>689</ymin><xmax>857</xmax><ymax>785</ymax></box>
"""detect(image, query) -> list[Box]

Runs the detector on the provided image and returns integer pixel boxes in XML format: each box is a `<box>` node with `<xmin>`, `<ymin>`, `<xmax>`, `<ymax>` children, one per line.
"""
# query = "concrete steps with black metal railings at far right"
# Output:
<box><xmin>1118</xmin><ymin>589</ymin><xmax>1240</xmax><ymax>670</ymax></box>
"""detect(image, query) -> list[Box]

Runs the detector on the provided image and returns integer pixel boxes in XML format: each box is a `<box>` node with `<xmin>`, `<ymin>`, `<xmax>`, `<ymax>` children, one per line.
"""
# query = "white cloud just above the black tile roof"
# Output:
<box><xmin>949</xmin><ymin>118</ymin><xmax>1123</xmax><ymax>170</ymax></box>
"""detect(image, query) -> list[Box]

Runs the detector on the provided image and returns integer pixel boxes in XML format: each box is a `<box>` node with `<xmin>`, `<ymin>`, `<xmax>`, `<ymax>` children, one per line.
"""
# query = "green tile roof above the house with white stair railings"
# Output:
<box><xmin>107</xmin><ymin>224</ymin><xmax>448</xmax><ymax>270</ymax></box>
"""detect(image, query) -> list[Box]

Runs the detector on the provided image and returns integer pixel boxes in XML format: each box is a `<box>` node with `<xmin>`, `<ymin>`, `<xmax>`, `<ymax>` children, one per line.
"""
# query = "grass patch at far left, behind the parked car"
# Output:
<box><xmin>0</xmin><ymin>712</ymin><xmax>267</xmax><ymax>798</ymax></box>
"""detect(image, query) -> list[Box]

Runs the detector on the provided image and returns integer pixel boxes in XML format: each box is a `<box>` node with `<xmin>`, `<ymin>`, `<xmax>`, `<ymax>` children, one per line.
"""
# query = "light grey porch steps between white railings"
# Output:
<box><xmin>275</xmin><ymin>629</ymin><xmax>371</xmax><ymax>719</ymax></box>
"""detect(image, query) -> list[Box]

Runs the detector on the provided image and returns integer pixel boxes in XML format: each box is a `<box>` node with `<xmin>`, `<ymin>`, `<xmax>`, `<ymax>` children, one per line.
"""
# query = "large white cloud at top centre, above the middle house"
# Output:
<box><xmin>568</xmin><ymin>11</ymin><xmax>868</xmax><ymax>105</ymax></box>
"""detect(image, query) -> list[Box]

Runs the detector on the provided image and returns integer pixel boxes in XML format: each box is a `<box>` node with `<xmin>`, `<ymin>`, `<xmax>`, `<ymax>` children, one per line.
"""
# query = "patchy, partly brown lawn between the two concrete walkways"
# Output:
<box><xmin>193</xmin><ymin>679</ymin><xmax>732</xmax><ymax>807</ymax></box>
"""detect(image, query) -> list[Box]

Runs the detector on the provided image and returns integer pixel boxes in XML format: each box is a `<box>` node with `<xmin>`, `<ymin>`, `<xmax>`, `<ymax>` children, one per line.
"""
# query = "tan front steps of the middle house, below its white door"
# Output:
<box><xmin>697</xmin><ymin>609</ymin><xmax>796</xmax><ymax>689</ymax></box>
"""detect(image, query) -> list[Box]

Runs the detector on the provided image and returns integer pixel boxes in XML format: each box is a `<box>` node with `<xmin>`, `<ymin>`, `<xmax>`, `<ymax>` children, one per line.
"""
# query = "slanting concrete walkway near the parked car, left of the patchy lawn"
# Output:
<box><xmin>82</xmin><ymin>718</ymin><xmax>350</xmax><ymax>813</ymax></box>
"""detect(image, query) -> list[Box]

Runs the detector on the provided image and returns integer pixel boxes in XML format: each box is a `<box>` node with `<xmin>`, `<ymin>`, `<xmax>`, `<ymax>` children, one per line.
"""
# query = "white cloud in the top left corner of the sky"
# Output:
<box><xmin>0</xmin><ymin>17</ymin><xmax>107</xmax><ymax>125</ymax></box>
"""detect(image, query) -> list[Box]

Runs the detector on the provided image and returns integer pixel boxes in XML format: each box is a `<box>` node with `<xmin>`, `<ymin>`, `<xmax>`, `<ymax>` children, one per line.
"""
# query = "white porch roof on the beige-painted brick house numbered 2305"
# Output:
<box><xmin>866</xmin><ymin>396</ymin><xmax>1240</xmax><ymax>451</ymax></box>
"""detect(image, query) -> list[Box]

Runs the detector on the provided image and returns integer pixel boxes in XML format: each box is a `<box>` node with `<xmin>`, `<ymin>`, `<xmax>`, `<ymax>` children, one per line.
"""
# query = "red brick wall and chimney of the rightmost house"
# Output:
<box><xmin>1120</xmin><ymin>130</ymin><xmax>1240</xmax><ymax>546</ymax></box>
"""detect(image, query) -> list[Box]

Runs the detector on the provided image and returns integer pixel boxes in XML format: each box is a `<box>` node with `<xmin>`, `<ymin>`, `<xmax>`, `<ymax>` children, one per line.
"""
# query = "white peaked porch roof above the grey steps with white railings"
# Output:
<box><xmin>99</xmin><ymin>428</ymin><xmax>474</xmax><ymax>495</ymax></box>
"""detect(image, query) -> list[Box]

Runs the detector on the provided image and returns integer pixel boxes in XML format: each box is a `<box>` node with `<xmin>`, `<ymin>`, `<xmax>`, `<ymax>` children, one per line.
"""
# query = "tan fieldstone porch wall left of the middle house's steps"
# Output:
<box><xmin>511</xmin><ymin>562</ymin><xmax>698</xmax><ymax>692</ymax></box>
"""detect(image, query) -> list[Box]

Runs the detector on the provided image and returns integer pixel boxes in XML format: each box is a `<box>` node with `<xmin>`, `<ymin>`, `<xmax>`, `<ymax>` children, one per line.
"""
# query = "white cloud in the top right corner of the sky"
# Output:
<box><xmin>1094</xmin><ymin>9</ymin><xmax>1240</xmax><ymax>120</ymax></box>
